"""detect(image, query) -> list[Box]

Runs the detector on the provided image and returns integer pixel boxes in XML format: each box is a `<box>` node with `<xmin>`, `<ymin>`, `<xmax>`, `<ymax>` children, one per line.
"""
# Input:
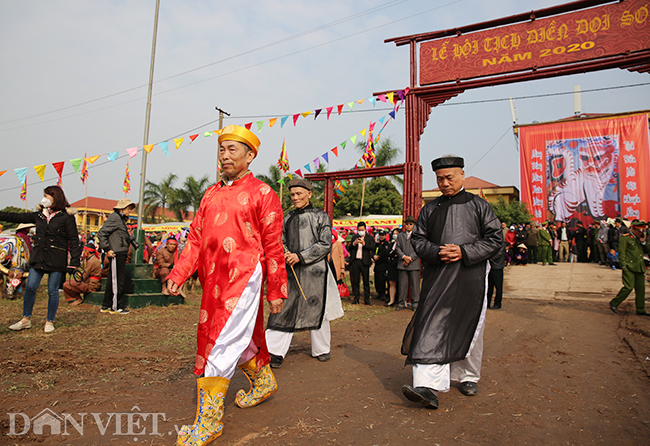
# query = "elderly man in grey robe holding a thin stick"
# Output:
<box><xmin>266</xmin><ymin>179</ymin><xmax>343</xmax><ymax>368</ymax></box>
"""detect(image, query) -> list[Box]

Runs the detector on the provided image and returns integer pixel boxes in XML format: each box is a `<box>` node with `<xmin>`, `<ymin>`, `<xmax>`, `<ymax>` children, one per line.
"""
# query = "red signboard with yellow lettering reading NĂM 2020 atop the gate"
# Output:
<box><xmin>420</xmin><ymin>0</ymin><xmax>650</xmax><ymax>85</ymax></box>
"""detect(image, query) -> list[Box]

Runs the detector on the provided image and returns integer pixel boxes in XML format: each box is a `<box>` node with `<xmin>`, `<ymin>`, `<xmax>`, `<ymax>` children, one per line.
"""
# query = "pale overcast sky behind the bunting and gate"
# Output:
<box><xmin>0</xmin><ymin>0</ymin><xmax>650</xmax><ymax>208</ymax></box>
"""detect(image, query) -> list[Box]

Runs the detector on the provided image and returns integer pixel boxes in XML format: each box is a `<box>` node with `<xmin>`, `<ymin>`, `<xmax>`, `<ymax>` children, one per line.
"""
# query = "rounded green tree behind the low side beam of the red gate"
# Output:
<box><xmin>334</xmin><ymin>177</ymin><xmax>402</xmax><ymax>218</ymax></box>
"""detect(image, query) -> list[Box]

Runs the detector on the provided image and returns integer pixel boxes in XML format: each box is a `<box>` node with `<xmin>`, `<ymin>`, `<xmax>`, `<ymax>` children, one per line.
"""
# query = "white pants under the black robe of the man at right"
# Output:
<box><xmin>413</xmin><ymin>321</ymin><xmax>485</xmax><ymax>392</ymax></box>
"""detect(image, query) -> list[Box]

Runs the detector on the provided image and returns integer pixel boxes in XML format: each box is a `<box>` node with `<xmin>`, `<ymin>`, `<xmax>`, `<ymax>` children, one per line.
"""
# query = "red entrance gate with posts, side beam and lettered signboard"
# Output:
<box><xmin>306</xmin><ymin>0</ymin><xmax>650</xmax><ymax>218</ymax></box>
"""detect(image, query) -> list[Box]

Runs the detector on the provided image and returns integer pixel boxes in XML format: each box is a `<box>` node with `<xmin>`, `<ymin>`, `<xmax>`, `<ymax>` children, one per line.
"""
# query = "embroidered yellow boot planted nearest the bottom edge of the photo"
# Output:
<box><xmin>176</xmin><ymin>376</ymin><xmax>230</xmax><ymax>446</ymax></box>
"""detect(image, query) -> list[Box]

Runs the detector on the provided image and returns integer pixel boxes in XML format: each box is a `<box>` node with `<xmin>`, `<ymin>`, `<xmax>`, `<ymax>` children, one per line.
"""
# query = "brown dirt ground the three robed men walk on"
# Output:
<box><xmin>0</xmin><ymin>265</ymin><xmax>650</xmax><ymax>446</ymax></box>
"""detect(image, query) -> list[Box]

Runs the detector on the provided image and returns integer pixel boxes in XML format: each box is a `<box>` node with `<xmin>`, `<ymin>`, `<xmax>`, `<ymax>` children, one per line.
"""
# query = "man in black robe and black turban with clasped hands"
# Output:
<box><xmin>402</xmin><ymin>156</ymin><xmax>503</xmax><ymax>409</ymax></box>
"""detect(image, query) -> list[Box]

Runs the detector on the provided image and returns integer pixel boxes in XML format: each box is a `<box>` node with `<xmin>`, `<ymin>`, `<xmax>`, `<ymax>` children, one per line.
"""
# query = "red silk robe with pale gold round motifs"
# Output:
<box><xmin>167</xmin><ymin>173</ymin><xmax>287</xmax><ymax>375</ymax></box>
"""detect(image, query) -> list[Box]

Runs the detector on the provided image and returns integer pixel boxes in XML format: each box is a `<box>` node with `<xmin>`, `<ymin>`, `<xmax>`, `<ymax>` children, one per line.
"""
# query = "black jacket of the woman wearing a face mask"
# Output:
<box><xmin>0</xmin><ymin>206</ymin><xmax>81</xmax><ymax>272</ymax></box>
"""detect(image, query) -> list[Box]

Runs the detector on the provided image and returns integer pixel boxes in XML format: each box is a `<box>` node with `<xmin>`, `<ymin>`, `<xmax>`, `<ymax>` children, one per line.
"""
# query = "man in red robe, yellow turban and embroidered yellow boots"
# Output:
<box><xmin>167</xmin><ymin>125</ymin><xmax>288</xmax><ymax>445</ymax></box>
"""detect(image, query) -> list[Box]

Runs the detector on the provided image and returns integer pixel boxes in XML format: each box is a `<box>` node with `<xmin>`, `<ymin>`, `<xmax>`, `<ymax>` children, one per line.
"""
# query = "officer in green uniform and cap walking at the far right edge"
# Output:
<box><xmin>609</xmin><ymin>221</ymin><xmax>650</xmax><ymax>316</ymax></box>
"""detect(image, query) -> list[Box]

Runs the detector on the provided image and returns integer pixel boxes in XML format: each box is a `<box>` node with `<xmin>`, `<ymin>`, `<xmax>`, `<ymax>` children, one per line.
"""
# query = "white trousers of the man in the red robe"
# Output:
<box><xmin>204</xmin><ymin>262</ymin><xmax>262</xmax><ymax>379</ymax></box>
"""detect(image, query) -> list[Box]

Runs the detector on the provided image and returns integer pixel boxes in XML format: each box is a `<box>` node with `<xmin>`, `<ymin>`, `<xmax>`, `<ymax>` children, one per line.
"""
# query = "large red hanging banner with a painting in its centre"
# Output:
<box><xmin>519</xmin><ymin>113</ymin><xmax>650</xmax><ymax>225</ymax></box>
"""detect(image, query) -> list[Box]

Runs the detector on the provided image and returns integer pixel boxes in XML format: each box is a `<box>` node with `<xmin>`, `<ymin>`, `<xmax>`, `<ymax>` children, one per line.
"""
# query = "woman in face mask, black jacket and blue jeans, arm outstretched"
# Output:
<box><xmin>0</xmin><ymin>186</ymin><xmax>81</xmax><ymax>333</ymax></box>
